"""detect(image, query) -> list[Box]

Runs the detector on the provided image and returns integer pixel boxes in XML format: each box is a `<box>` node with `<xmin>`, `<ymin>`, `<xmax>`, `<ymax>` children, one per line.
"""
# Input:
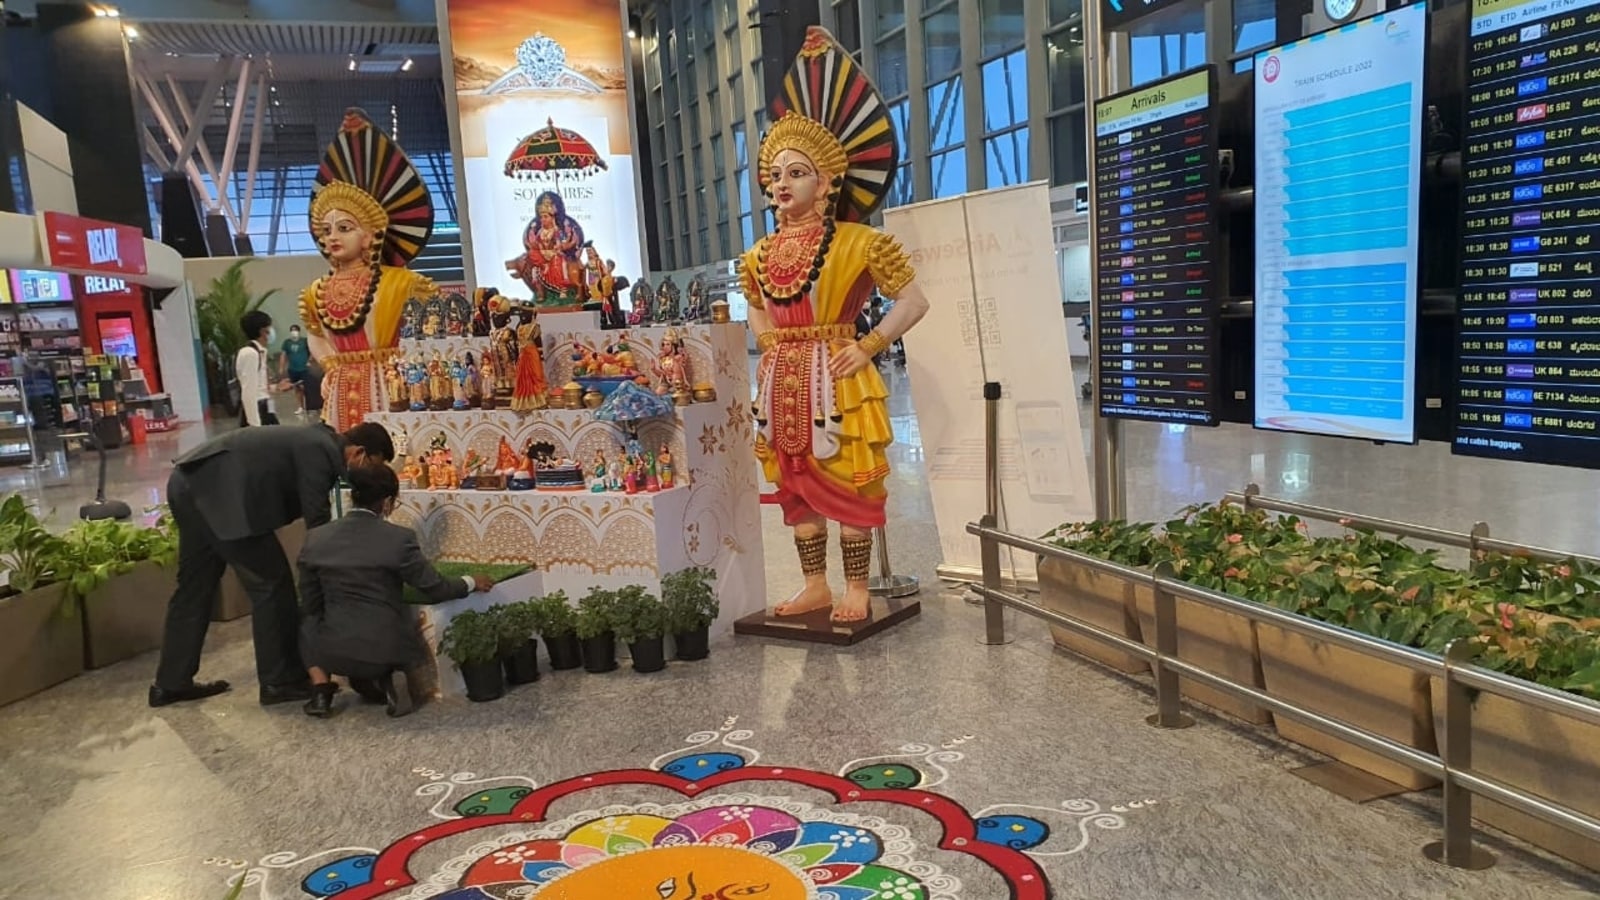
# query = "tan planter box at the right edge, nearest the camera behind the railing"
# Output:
<box><xmin>1432</xmin><ymin>677</ymin><xmax>1600</xmax><ymax>871</ymax></box>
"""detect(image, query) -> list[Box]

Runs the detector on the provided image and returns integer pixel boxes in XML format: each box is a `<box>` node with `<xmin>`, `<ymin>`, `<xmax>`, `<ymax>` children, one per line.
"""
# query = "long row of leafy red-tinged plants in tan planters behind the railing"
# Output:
<box><xmin>1040</xmin><ymin>504</ymin><xmax>1600</xmax><ymax>868</ymax></box>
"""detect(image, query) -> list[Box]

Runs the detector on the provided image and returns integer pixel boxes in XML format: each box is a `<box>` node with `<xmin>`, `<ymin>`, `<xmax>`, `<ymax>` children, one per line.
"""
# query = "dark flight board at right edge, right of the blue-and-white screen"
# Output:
<box><xmin>1453</xmin><ymin>0</ymin><xmax>1600</xmax><ymax>468</ymax></box>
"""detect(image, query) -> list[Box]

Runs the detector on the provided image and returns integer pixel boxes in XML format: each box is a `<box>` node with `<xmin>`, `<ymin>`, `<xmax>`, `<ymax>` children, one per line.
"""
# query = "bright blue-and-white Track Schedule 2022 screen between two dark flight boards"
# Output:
<box><xmin>1254</xmin><ymin>3</ymin><xmax>1427</xmax><ymax>444</ymax></box>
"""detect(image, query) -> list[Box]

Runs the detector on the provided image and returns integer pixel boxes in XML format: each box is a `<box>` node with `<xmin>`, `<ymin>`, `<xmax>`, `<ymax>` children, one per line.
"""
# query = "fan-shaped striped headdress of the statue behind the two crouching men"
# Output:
<box><xmin>310</xmin><ymin>107</ymin><xmax>434</xmax><ymax>266</ymax></box>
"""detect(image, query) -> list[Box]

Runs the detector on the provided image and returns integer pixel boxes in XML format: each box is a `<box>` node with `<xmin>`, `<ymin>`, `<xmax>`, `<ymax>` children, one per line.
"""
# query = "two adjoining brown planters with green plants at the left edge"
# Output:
<box><xmin>0</xmin><ymin>495</ymin><xmax>178</xmax><ymax>706</ymax></box>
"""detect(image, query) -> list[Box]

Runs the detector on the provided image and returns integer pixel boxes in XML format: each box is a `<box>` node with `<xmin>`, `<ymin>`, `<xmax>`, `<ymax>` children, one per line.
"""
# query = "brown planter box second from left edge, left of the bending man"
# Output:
<box><xmin>82</xmin><ymin>562</ymin><xmax>178</xmax><ymax>669</ymax></box>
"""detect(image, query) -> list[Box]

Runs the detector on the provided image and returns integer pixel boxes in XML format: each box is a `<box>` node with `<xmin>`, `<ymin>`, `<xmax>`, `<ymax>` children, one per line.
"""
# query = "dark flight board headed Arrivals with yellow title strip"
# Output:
<box><xmin>1094</xmin><ymin>69</ymin><xmax>1218</xmax><ymax>424</ymax></box>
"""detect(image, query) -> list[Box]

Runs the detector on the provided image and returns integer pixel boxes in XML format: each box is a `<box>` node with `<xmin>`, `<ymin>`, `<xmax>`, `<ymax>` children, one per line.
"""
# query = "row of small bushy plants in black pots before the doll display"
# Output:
<box><xmin>438</xmin><ymin>567</ymin><xmax>720</xmax><ymax>701</ymax></box>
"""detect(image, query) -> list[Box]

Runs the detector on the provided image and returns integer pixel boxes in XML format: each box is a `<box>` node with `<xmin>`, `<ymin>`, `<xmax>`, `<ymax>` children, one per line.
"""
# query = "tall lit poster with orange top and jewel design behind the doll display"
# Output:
<box><xmin>438</xmin><ymin>0</ymin><xmax>643</xmax><ymax>307</ymax></box>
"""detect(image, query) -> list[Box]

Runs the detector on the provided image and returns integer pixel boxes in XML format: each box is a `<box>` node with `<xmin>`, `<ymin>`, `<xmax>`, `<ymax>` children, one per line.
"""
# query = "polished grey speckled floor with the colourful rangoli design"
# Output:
<box><xmin>0</xmin><ymin>368</ymin><xmax>1600</xmax><ymax>900</ymax></box>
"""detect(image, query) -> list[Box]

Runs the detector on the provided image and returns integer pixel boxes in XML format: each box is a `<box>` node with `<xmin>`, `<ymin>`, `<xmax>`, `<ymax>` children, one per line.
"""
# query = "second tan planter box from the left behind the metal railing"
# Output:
<box><xmin>1134</xmin><ymin>591</ymin><xmax>1272</xmax><ymax>725</ymax></box>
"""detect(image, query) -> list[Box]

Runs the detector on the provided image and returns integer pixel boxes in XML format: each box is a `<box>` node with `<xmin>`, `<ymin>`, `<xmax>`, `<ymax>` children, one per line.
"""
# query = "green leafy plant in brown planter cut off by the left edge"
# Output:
<box><xmin>0</xmin><ymin>493</ymin><xmax>83</xmax><ymax>706</ymax></box>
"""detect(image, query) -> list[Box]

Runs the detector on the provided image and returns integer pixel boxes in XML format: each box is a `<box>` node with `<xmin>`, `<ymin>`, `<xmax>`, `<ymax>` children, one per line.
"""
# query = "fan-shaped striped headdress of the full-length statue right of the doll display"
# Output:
<box><xmin>758</xmin><ymin>26</ymin><xmax>899</xmax><ymax>221</ymax></box>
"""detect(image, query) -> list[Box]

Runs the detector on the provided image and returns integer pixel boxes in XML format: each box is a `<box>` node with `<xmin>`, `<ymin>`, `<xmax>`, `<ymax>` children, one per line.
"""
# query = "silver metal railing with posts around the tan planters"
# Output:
<box><xmin>966</xmin><ymin>383</ymin><xmax>1600</xmax><ymax>868</ymax></box>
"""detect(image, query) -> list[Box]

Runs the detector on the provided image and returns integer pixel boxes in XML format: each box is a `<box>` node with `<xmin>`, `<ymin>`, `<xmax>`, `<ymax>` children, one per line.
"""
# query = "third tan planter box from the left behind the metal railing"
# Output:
<box><xmin>1256</xmin><ymin>623</ymin><xmax>1438</xmax><ymax>790</ymax></box>
